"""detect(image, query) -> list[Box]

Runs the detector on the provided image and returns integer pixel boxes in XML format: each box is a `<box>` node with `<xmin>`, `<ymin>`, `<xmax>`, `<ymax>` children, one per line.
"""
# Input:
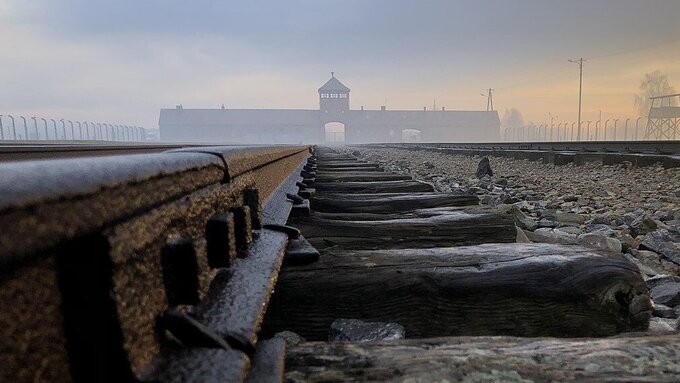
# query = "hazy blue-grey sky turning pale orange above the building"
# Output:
<box><xmin>0</xmin><ymin>0</ymin><xmax>680</xmax><ymax>127</ymax></box>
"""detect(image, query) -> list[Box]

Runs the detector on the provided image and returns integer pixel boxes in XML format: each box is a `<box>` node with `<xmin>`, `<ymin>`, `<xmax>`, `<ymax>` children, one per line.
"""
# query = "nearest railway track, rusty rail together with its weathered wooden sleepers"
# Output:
<box><xmin>0</xmin><ymin>142</ymin><xmax>680</xmax><ymax>382</ymax></box>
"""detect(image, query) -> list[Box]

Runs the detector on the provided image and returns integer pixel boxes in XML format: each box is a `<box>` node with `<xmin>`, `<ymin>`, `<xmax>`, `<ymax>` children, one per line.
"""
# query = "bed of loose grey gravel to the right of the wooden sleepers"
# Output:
<box><xmin>341</xmin><ymin>146</ymin><xmax>680</xmax><ymax>327</ymax></box>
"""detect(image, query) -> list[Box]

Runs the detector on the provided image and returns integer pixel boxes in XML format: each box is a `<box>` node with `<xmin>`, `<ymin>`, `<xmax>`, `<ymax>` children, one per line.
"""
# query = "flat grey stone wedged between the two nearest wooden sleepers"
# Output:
<box><xmin>328</xmin><ymin>319</ymin><xmax>406</xmax><ymax>342</ymax></box>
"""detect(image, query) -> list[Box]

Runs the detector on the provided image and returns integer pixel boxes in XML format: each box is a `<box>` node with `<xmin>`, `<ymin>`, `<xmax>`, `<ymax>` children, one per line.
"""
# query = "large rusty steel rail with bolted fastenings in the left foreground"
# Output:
<box><xmin>0</xmin><ymin>146</ymin><xmax>310</xmax><ymax>382</ymax></box>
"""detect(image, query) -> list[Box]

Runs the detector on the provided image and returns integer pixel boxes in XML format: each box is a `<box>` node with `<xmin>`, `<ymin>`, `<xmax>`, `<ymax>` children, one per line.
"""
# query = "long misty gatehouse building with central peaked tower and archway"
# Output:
<box><xmin>159</xmin><ymin>74</ymin><xmax>500</xmax><ymax>144</ymax></box>
